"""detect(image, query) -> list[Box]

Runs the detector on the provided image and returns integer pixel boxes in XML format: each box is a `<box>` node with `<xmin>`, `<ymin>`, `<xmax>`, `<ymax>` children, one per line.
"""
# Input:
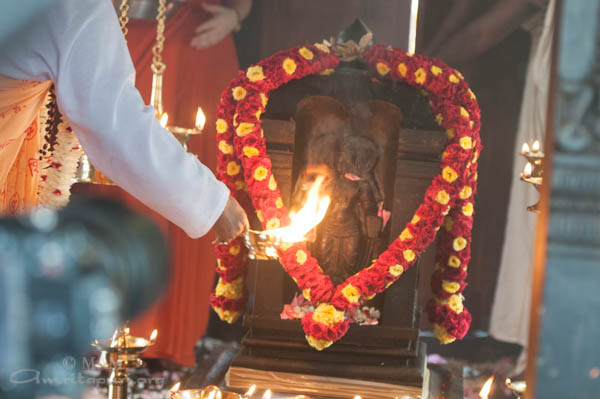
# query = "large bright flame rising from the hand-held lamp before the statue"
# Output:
<box><xmin>268</xmin><ymin>176</ymin><xmax>331</xmax><ymax>243</ymax></box>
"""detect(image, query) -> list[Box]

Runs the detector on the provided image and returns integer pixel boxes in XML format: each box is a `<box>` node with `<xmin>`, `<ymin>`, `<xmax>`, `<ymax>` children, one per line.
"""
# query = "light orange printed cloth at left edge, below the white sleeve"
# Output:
<box><xmin>0</xmin><ymin>76</ymin><xmax>51</xmax><ymax>215</ymax></box>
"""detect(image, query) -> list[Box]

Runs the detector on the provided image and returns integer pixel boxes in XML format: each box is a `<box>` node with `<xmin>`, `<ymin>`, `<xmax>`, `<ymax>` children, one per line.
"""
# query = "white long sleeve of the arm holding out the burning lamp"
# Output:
<box><xmin>0</xmin><ymin>0</ymin><xmax>229</xmax><ymax>238</ymax></box>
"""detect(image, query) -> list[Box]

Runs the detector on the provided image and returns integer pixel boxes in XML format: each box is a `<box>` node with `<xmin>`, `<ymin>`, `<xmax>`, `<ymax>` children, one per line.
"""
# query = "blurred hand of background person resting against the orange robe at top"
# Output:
<box><xmin>190</xmin><ymin>3</ymin><xmax>241</xmax><ymax>49</ymax></box>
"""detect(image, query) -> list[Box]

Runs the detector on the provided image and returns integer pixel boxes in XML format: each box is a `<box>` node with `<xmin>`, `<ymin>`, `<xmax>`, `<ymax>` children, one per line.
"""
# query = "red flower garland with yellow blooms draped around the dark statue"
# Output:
<box><xmin>211</xmin><ymin>44</ymin><xmax>481</xmax><ymax>350</ymax></box>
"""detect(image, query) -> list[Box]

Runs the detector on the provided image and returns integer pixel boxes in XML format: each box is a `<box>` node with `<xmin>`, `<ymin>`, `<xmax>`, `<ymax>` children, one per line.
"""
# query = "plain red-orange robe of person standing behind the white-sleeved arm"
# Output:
<box><xmin>78</xmin><ymin>0</ymin><xmax>238</xmax><ymax>366</ymax></box>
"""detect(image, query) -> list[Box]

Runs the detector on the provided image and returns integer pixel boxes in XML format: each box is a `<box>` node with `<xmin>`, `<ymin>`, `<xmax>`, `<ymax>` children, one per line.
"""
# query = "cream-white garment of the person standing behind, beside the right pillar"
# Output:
<box><xmin>490</xmin><ymin>0</ymin><xmax>555</xmax><ymax>347</ymax></box>
